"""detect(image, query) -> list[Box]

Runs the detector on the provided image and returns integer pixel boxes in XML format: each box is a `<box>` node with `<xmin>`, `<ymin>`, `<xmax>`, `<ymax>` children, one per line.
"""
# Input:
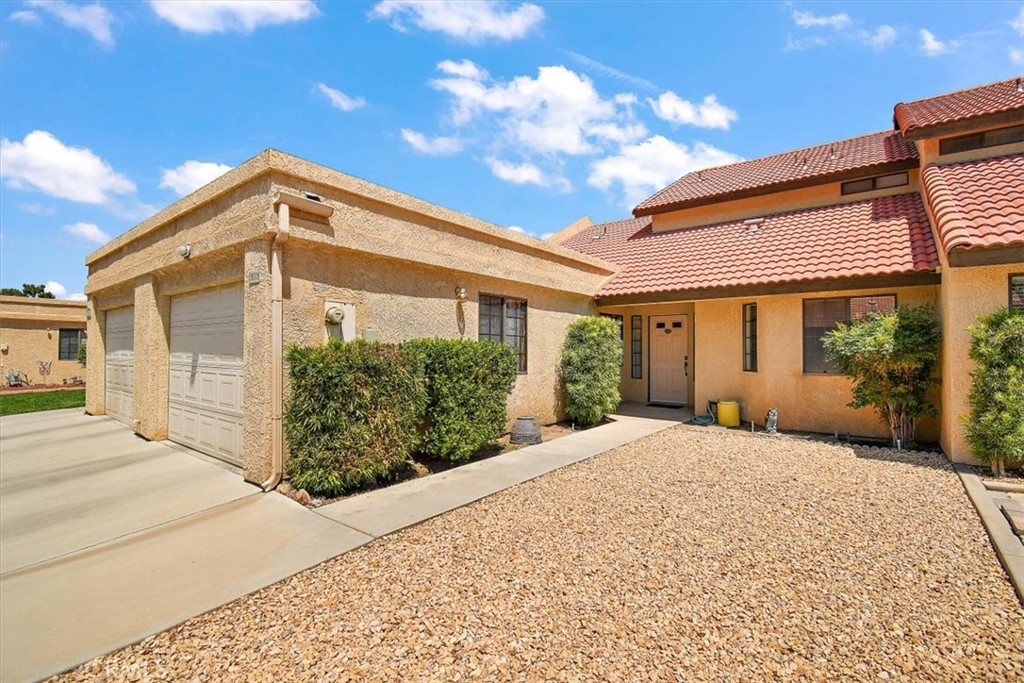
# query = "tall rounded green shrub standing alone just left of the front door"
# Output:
<box><xmin>560</xmin><ymin>315</ymin><xmax>623</xmax><ymax>425</ymax></box>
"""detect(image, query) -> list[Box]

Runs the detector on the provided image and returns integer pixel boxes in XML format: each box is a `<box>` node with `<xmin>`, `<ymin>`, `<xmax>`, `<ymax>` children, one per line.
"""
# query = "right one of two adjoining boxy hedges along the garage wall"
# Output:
<box><xmin>404</xmin><ymin>339</ymin><xmax>516</xmax><ymax>462</ymax></box>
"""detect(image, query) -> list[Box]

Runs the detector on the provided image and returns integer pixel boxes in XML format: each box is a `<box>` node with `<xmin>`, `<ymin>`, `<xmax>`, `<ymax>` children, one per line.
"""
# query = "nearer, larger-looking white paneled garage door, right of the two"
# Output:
<box><xmin>168</xmin><ymin>285</ymin><xmax>243</xmax><ymax>465</ymax></box>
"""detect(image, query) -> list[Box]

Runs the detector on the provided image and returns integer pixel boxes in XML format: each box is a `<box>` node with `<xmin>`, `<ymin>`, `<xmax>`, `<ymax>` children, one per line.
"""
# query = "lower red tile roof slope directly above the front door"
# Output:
<box><xmin>562</xmin><ymin>193</ymin><xmax>939</xmax><ymax>297</ymax></box>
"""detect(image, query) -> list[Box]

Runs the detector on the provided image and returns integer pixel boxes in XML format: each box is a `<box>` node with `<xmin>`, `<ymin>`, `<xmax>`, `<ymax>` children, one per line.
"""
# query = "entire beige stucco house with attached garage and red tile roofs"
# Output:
<box><xmin>86</xmin><ymin>81</ymin><xmax>1024</xmax><ymax>487</ymax></box>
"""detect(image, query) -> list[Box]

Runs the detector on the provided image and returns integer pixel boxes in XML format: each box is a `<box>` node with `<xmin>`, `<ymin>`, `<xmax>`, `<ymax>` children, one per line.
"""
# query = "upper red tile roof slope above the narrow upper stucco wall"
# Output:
<box><xmin>633</xmin><ymin>130</ymin><xmax>918</xmax><ymax>216</ymax></box>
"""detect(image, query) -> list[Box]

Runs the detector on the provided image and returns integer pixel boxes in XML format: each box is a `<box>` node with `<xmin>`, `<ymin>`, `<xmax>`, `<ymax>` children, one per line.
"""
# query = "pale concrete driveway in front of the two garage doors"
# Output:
<box><xmin>0</xmin><ymin>410</ymin><xmax>371</xmax><ymax>683</ymax></box>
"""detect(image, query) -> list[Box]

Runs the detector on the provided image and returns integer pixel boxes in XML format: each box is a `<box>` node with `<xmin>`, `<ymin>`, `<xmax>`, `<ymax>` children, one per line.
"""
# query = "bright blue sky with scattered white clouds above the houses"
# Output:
<box><xmin>0</xmin><ymin>0</ymin><xmax>1024</xmax><ymax>297</ymax></box>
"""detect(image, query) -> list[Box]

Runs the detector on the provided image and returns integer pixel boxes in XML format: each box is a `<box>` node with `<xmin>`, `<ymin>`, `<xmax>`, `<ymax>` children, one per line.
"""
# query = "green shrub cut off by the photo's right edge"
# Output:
<box><xmin>965</xmin><ymin>308</ymin><xmax>1024</xmax><ymax>472</ymax></box>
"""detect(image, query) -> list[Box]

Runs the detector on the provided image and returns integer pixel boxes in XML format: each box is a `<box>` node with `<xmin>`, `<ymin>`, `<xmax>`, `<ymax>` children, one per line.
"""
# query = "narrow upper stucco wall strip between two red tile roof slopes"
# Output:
<box><xmin>651</xmin><ymin>168</ymin><xmax>921</xmax><ymax>231</ymax></box>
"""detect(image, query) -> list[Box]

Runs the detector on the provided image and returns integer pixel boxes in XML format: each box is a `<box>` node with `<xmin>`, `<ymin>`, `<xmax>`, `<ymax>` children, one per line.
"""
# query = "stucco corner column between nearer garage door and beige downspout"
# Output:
<box><xmin>242</xmin><ymin>240</ymin><xmax>271</xmax><ymax>483</ymax></box>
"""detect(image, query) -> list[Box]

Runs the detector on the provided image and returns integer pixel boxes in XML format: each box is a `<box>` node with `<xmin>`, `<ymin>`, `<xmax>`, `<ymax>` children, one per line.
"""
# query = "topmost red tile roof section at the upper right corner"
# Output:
<box><xmin>893</xmin><ymin>79</ymin><xmax>1024</xmax><ymax>136</ymax></box>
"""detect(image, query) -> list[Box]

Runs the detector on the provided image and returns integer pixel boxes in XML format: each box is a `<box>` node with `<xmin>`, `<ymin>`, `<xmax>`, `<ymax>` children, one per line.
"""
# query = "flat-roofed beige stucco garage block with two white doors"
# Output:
<box><xmin>86</xmin><ymin>151</ymin><xmax>613</xmax><ymax>483</ymax></box>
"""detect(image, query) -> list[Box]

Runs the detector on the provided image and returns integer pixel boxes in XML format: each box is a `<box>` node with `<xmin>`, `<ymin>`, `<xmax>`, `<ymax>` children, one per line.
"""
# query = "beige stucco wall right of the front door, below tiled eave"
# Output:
<box><xmin>638</xmin><ymin>286</ymin><xmax>939</xmax><ymax>441</ymax></box>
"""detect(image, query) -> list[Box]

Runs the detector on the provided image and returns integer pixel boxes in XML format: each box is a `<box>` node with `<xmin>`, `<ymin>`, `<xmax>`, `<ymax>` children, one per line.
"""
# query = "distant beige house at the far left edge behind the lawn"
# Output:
<box><xmin>0</xmin><ymin>296</ymin><xmax>86</xmax><ymax>388</ymax></box>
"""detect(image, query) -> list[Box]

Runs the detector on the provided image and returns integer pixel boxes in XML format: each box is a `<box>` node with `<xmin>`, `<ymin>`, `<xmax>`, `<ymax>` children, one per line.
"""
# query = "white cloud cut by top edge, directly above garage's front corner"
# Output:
<box><xmin>150</xmin><ymin>0</ymin><xmax>319</xmax><ymax>34</ymax></box>
